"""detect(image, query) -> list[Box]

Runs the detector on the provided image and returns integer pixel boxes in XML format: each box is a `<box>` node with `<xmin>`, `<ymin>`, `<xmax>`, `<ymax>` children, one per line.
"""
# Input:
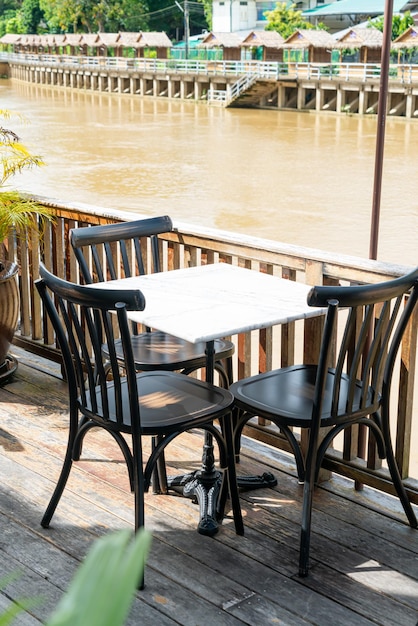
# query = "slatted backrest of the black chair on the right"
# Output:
<box><xmin>308</xmin><ymin>268</ymin><xmax>418</xmax><ymax>421</ymax></box>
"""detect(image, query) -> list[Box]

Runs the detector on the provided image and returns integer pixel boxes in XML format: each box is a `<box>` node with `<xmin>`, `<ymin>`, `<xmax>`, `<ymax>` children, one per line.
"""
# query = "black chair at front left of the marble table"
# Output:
<box><xmin>36</xmin><ymin>266</ymin><xmax>244</xmax><ymax>584</ymax></box>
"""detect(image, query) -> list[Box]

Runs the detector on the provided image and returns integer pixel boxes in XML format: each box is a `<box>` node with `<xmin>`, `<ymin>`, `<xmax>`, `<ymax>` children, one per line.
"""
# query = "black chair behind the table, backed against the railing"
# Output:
<box><xmin>70</xmin><ymin>215</ymin><xmax>235</xmax><ymax>387</ymax></box>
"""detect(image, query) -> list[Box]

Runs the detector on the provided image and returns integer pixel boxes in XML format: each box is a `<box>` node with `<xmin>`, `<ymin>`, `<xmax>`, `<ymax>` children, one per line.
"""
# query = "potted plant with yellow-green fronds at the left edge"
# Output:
<box><xmin>0</xmin><ymin>110</ymin><xmax>52</xmax><ymax>384</ymax></box>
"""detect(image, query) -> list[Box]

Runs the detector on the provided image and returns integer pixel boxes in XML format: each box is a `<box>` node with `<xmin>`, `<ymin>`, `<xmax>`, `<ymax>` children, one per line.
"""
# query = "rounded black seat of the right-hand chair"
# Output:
<box><xmin>230</xmin><ymin>365</ymin><xmax>371</xmax><ymax>428</ymax></box>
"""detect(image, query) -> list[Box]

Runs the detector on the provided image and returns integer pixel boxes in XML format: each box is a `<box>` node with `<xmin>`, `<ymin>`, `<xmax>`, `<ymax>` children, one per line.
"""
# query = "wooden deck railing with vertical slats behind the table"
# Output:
<box><xmin>8</xmin><ymin>198</ymin><xmax>418</xmax><ymax>503</ymax></box>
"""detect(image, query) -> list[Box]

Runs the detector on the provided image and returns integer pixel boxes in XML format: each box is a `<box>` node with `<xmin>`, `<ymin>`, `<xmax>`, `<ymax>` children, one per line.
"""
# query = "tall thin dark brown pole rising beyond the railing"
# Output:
<box><xmin>369</xmin><ymin>0</ymin><xmax>393</xmax><ymax>259</ymax></box>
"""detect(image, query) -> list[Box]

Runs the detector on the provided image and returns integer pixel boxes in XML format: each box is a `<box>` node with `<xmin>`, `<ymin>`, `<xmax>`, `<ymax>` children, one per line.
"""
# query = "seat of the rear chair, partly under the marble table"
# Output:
<box><xmin>103</xmin><ymin>331</ymin><xmax>235</xmax><ymax>371</ymax></box>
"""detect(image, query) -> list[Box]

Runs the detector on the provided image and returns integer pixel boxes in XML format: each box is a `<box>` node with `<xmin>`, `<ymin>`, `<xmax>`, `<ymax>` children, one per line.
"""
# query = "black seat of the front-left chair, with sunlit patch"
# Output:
<box><xmin>80</xmin><ymin>371</ymin><xmax>234</xmax><ymax>435</ymax></box>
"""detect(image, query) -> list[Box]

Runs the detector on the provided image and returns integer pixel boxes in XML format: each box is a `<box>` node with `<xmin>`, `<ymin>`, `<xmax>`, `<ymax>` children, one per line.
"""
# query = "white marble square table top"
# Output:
<box><xmin>95</xmin><ymin>263</ymin><xmax>322</xmax><ymax>343</ymax></box>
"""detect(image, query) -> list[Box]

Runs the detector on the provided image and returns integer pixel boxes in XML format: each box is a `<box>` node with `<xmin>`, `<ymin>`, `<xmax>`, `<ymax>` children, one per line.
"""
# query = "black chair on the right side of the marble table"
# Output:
<box><xmin>230</xmin><ymin>268</ymin><xmax>418</xmax><ymax>576</ymax></box>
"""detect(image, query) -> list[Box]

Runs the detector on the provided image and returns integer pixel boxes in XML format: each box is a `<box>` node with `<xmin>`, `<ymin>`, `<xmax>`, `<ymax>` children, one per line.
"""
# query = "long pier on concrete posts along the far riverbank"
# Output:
<box><xmin>0</xmin><ymin>53</ymin><xmax>418</xmax><ymax>119</ymax></box>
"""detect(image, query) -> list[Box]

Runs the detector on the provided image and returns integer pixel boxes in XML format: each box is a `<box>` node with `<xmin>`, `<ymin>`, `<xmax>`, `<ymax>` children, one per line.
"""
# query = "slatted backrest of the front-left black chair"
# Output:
<box><xmin>36</xmin><ymin>265</ymin><xmax>145</xmax><ymax>432</ymax></box>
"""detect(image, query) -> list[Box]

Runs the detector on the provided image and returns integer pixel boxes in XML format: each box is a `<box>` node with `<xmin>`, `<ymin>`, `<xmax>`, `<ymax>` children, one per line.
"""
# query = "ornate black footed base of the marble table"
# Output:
<box><xmin>167</xmin><ymin>470</ymin><xmax>277</xmax><ymax>537</ymax></box>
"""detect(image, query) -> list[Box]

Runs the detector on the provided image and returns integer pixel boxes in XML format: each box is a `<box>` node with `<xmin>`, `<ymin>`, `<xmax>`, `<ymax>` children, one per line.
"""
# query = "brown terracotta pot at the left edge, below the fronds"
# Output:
<box><xmin>0</xmin><ymin>261</ymin><xmax>20</xmax><ymax>382</ymax></box>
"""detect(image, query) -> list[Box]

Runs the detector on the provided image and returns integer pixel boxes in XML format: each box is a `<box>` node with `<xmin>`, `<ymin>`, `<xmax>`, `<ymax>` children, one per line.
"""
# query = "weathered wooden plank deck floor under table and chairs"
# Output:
<box><xmin>0</xmin><ymin>350</ymin><xmax>418</xmax><ymax>626</ymax></box>
